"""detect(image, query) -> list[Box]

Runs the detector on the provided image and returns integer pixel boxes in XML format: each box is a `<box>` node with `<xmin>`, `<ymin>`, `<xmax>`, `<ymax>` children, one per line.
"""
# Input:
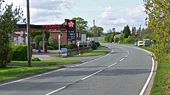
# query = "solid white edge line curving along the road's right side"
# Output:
<box><xmin>139</xmin><ymin>57</ymin><xmax>155</xmax><ymax>95</ymax></box>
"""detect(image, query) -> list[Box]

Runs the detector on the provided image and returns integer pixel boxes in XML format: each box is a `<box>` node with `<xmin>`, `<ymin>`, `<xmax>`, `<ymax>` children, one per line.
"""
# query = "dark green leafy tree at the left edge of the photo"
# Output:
<box><xmin>0</xmin><ymin>0</ymin><xmax>23</xmax><ymax>67</ymax></box>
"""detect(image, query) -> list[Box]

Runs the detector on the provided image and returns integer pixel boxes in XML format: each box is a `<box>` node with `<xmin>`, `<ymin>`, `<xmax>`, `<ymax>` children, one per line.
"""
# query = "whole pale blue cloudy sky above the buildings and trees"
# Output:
<box><xmin>5</xmin><ymin>0</ymin><xmax>146</xmax><ymax>32</ymax></box>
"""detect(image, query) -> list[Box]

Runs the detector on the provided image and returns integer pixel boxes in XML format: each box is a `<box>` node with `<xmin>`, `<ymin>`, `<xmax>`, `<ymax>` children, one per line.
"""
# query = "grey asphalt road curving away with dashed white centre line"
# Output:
<box><xmin>0</xmin><ymin>44</ymin><xmax>152</xmax><ymax>95</ymax></box>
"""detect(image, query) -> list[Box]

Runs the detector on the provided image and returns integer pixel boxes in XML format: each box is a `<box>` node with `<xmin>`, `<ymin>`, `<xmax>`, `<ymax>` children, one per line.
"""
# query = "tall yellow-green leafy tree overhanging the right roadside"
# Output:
<box><xmin>144</xmin><ymin>0</ymin><xmax>170</xmax><ymax>57</ymax></box>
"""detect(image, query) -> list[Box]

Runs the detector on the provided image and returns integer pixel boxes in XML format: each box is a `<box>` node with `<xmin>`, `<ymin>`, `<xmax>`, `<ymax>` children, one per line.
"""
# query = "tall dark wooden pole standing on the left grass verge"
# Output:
<box><xmin>27</xmin><ymin>0</ymin><xmax>32</xmax><ymax>67</ymax></box>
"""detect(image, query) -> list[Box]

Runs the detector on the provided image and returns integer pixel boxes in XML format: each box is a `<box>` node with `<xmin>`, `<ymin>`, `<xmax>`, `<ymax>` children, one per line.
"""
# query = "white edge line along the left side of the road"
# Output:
<box><xmin>0</xmin><ymin>47</ymin><xmax>114</xmax><ymax>86</ymax></box>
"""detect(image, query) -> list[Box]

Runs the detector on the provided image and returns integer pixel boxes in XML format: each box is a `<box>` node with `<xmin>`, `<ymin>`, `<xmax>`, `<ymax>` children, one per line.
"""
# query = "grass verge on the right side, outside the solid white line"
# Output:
<box><xmin>142</xmin><ymin>47</ymin><xmax>170</xmax><ymax>95</ymax></box>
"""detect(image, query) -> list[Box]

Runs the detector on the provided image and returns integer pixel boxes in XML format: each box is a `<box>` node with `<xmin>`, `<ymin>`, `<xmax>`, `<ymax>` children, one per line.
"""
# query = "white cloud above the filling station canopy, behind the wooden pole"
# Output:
<box><xmin>6</xmin><ymin>0</ymin><xmax>72</xmax><ymax>24</ymax></box>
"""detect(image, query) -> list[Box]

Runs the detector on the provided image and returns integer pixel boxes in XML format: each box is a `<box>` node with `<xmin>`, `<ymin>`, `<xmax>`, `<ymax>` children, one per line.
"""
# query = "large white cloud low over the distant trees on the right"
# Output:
<box><xmin>99</xmin><ymin>5</ymin><xmax>146</xmax><ymax>30</ymax></box>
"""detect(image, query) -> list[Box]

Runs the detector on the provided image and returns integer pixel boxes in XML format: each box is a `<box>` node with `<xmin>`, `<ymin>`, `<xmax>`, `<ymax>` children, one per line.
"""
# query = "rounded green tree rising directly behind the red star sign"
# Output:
<box><xmin>73</xmin><ymin>17</ymin><xmax>88</xmax><ymax>33</ymax></box>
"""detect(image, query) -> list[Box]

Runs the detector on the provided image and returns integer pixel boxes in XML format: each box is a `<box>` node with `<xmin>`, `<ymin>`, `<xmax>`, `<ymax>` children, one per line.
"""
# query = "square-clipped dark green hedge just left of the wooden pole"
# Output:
<box><xmin>12</xmin><ymin>45</ymin><xmax>27</xmax><ymax>61</ymax></box>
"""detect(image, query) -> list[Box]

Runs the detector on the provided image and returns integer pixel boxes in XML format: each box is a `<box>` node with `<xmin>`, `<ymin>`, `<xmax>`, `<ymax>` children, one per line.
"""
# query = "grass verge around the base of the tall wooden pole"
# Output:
<box><xmin>0</xmin><ymin>60</ymin><xmax>80</xmax><ymax>82</ymax></box>
